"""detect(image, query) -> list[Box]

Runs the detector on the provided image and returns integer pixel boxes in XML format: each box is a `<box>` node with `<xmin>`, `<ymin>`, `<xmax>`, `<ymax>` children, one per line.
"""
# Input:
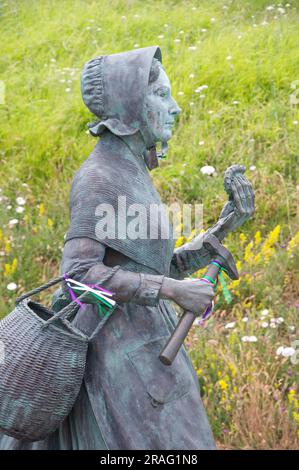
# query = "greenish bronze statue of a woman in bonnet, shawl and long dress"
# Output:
<box><xmin>0</xmin><ymin>47</ymin><xmax>254</xmax><ymax>450</ymax></box>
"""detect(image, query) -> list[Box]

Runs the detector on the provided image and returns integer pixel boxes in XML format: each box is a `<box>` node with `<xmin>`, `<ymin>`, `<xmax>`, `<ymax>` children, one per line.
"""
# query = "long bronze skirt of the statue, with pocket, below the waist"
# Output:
<box><xmin>0</xmin><ymin>240</ymin><xmax>215</xmax><ymax>450</ymax></box>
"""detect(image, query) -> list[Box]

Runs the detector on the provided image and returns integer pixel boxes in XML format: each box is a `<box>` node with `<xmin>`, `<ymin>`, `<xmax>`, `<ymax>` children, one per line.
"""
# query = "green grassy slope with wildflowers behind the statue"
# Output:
<box><xmin>0</xmin><ymin>0</ymin><xmax>299</xmax><ymax>448</ymax></box>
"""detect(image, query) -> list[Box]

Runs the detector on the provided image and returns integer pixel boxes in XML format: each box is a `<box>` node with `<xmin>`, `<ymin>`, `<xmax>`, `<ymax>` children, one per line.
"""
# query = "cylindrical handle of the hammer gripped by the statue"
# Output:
<box><xmin>159</xmin><ymin>264</ymin><xmax>219</xmax><ymax>366</ymax></box>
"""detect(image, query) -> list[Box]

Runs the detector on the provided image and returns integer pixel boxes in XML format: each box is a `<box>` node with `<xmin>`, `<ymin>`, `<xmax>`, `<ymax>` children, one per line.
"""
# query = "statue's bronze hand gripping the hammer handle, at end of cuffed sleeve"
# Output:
<box><xmin>161</xmin><ymin>278</ymin><xmax>215</xmax><ymax>316</ymax></box>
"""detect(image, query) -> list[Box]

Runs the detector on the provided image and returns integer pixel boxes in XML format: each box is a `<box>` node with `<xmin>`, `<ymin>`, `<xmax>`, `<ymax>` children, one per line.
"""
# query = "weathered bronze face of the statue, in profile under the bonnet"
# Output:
<box><xmin>144</xmin><ymin>68</ymin><xmax>182</xmax><ymax>143</ymax></box>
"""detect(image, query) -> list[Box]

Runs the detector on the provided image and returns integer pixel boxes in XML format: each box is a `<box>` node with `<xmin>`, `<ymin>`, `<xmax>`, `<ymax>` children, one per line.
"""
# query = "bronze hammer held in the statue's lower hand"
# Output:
<box><xmin>159</xmin><ymin>234</ymin><xmax>239</xmax><ymax>366</ymax></box>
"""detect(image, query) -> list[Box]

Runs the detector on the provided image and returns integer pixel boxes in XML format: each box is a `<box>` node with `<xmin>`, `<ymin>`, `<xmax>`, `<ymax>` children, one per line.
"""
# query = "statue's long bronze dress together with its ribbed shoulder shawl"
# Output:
<box><xmin>0</xmin><ymin>127</ymin><xmax>215</xmax><ymax>450</ymax></box>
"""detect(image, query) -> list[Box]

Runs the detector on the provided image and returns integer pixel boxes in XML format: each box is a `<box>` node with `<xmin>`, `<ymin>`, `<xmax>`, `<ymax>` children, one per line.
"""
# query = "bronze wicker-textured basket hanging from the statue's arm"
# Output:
<box><xmin>0</xmin><ymin>266</ymin><xmax>119</xmax><ymax>441</ymax></box>
